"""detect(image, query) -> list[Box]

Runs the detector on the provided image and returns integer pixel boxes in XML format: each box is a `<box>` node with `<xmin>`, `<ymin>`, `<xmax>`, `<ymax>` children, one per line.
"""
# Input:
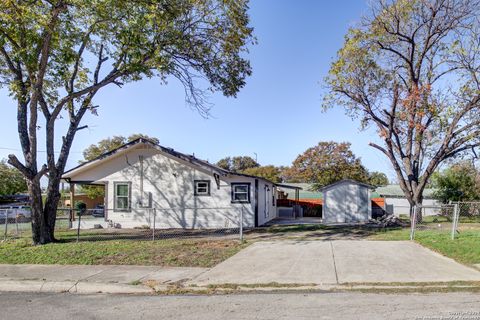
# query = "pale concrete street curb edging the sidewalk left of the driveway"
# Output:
<box><xmin>0</xmin><ymin>280</ymin><xmax>154</xmax><ymax>294</ymax></box>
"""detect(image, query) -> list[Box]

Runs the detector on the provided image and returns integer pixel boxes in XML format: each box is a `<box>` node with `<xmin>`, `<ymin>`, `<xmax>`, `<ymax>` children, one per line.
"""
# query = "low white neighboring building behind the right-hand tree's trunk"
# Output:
<box><xmin>376</xmin><ymin>184</ymin><xmax>441</xmax><ymax>217</ymax></box>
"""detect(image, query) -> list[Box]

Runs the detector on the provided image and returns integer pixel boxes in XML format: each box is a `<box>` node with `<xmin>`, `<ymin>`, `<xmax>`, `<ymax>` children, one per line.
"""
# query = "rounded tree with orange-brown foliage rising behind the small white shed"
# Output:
<box><xmin>286</xmin><ymin>141</ymin><xmax>368</xmax><ymax>188</ymax></box>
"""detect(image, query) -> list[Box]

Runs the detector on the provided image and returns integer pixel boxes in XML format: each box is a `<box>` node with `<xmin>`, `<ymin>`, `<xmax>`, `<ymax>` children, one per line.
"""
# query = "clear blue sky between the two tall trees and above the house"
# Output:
<box><xmin>0</xmin><ymin>0</ymin><xmax>393</xmax><ymax>178</ymax></box>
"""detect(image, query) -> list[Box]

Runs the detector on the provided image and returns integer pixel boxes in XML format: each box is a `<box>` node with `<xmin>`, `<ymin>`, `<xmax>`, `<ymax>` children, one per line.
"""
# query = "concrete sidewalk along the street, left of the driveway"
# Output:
<box><xmin>0</xmin><ymin>265</ymin><xmax>208</xmax><ymax>293</ymax></box>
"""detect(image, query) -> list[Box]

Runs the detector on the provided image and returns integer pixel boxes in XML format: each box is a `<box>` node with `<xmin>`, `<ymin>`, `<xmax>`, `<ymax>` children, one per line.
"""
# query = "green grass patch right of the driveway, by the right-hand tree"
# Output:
<box><xmin>371</xmin><ymin>229</ymin><xmax>480</xmax><ymax>265</ymax></box>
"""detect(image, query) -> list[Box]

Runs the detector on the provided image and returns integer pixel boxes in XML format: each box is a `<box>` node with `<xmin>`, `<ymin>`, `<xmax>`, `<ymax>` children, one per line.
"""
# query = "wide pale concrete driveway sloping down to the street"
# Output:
<box><xmin>192</xmin><ymin>240</ymin><xmax>480</xmax><ymax>285</ymax></box>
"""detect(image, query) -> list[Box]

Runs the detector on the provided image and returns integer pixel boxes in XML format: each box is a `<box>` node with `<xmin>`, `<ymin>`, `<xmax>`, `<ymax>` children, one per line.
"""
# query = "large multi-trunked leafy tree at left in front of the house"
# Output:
<box><xmin>0</xmin><ymin>0</ymin><xmax>254</xmax><ymax>244</ymax></box>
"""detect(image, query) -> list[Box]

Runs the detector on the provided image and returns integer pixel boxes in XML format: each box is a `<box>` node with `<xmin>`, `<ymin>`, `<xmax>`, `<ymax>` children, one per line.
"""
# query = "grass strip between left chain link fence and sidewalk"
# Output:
<box><xmin>0</xmin><ymin>239</ymin><xmax>247</xmax><ymax>267</ymax></box>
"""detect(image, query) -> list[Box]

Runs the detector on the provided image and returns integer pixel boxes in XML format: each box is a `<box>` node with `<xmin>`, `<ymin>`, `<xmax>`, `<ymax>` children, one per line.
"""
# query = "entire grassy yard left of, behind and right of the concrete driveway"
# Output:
<box><xmin>0</xmin><ymin>219</ymin><xmax>480</xmax><ymax>267</ymax></box>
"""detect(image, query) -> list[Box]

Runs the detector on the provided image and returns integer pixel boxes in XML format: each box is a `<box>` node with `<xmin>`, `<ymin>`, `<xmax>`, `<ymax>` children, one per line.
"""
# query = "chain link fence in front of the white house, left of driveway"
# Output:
<box><xmin>0</xmin><ymin>207</ymin><xmax>245</xmax><ymax>242</ymax></box>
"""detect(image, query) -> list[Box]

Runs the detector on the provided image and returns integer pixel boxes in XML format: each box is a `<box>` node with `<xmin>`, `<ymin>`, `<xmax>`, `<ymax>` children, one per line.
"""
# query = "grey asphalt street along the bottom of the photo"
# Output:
<box><xmin>0</xmin><ymin>293</ymin><xmax>480</xmax><ymax>320</ymax></box>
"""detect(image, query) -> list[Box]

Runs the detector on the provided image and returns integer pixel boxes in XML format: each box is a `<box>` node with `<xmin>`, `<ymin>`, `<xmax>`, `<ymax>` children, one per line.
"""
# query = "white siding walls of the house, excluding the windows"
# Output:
<box><xmin>66</xmin><ymin>147</ymin><xmax>275</xmax><ymax>229</ymax></box>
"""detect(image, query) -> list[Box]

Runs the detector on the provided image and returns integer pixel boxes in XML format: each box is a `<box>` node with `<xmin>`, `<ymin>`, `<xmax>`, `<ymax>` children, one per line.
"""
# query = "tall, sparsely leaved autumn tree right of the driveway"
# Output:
<box><xmin>324</xmin><ymin>0</ymin><xmax>480</xmax><ymax>219</ymax></box>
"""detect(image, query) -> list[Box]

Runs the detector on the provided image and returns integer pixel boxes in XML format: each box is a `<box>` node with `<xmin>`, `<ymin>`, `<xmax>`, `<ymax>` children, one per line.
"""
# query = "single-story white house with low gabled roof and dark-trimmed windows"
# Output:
<box><xmin>63</xmin><ymin>138</ymin><xmax>284</xmax><ymax>228</ymax></box>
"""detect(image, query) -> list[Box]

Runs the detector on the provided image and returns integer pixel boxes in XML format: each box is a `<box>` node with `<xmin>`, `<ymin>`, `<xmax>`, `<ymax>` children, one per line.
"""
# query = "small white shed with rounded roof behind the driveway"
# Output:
<box><xmin>320</xmin><ymin>179</ymin><xmax>374</xmax><ymax>223</ymax></box>
